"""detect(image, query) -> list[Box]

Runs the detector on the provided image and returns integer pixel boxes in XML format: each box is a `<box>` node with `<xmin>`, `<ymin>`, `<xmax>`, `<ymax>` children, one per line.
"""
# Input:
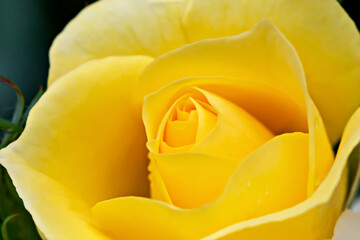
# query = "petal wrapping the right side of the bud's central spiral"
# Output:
<box><xmin>190</xmin><ymin>89</ymin><xmax>274</xmax><ymax>159</ymax></box>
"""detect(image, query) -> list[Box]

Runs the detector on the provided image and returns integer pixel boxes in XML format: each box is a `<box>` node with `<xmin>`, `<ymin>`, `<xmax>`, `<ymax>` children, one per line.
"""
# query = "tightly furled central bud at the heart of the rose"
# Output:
<box><xmin>148</xmin><ymin>88</ymin><xmax>274</xmax><ymax>209</ymax></box>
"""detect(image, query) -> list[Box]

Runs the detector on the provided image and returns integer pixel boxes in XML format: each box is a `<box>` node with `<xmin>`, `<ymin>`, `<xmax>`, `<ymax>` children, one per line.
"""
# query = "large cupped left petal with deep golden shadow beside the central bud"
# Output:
<box><xmin>0</xmin><ymin>56</ymin><xmax>152</xmax><ymax>239</ymax></box>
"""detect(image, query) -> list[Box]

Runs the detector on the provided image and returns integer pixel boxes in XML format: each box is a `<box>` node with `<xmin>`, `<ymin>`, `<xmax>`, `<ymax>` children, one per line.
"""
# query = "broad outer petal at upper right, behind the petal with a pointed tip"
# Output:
<box><xmin>184</xmin><ymin>0</ymin><xmax>360</xmax><ymax>142</ymax></box>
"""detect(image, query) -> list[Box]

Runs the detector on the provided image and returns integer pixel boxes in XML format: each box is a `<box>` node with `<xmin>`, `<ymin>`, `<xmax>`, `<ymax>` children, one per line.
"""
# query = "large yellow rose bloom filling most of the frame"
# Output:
<box><xmin>0</xmin><ymin>0</ymin><xmax>360</xmax><ymax>240</ymax></box>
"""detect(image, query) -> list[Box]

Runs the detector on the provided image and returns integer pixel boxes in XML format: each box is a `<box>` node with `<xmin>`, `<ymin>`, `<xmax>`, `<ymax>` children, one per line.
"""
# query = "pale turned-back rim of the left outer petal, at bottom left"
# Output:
<box><xmin>0</xmin><ymin>158</ymin><xmax>110</xmax><ymax>240</ymax></box>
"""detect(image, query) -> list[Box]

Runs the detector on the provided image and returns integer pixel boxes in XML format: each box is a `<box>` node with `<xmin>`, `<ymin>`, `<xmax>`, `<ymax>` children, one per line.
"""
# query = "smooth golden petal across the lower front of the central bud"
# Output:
<box><xmin>150</xmin><ymin>153</ymin><xmax>238</xmax><ymax>208</ymax></box>
